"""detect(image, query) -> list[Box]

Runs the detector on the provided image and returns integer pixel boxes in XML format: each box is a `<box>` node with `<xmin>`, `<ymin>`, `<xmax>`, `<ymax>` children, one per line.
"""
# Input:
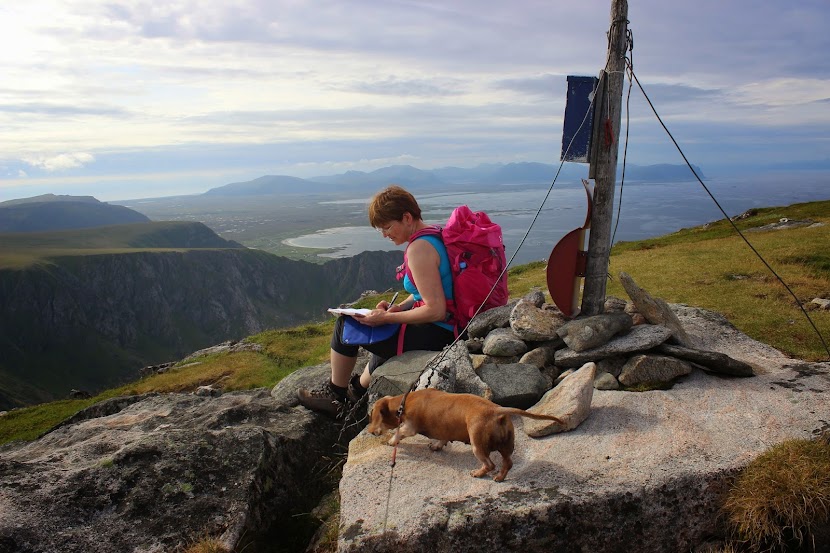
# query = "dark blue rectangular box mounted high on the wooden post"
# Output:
<box><xmin>561</xmin><ymin>75</ymin><xmax>599</xmax><ymax>163</ymax></box>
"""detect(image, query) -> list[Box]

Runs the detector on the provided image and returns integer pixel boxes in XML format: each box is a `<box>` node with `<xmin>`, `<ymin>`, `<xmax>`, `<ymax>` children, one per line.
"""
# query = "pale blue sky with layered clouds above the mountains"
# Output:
<box><xmin>0</xmin><ymin>0</ymin><xmax>830</xmax><ymax>201</ymax></box>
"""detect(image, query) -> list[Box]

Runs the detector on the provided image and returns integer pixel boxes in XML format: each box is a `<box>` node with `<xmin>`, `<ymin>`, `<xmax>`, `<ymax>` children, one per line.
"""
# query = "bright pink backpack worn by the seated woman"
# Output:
<box><xmin>398</xmin><ymin>205</ymin><xmax>508</xmax><ymax>332</ymax></box>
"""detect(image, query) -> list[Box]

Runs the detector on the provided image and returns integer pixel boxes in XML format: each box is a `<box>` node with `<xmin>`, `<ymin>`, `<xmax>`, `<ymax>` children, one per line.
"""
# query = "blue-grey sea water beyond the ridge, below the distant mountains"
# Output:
<box><xmin>285</xmin><ymin>173</ymin><xmax>830</xmax><ymax>265</ymax></box>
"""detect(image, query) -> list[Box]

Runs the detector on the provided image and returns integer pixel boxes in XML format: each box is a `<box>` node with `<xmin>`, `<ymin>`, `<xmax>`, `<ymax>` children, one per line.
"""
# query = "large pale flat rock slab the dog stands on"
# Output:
<box><xmin>338</xmin><ymin>306</ymin><xmax>830</xmax><ymax>553</ymax></box>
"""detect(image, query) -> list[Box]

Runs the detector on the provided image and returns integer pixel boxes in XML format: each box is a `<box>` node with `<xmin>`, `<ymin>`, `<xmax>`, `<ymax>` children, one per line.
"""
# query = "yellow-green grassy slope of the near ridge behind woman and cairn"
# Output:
<box><xmin>0</xmin><ymin>201</ymin><xmax>830</xmax><ymax>443</ymax></box>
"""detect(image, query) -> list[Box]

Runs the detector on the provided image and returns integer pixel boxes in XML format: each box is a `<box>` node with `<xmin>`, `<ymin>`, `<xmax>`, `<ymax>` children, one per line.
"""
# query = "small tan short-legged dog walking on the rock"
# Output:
<box><xmin>366</xmin><ymin>388</ymin><xmax>562</xmax><ymax>482</ymax></box>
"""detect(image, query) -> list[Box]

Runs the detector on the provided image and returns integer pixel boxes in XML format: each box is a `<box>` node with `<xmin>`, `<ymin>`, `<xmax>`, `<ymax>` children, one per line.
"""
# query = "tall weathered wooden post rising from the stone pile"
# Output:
<box><xmin>580</xmin><ymin>0</ymin><xmax>628</xmax><ymax>316</ymax></box>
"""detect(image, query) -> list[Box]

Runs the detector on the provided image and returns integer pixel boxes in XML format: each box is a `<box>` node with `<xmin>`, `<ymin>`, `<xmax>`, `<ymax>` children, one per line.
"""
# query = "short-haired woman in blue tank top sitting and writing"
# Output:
<box><xmin>297</xmin><ymin>185</ymin><xmax>455</xmax><ymax>417</ymax></box>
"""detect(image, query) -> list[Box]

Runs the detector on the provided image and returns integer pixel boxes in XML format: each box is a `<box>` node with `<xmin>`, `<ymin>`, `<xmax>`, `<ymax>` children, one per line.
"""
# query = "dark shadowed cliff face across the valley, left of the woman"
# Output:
<box><xmin>0</xmin><ymin>249</ymin><xmax>401</xmax><ymax>409</ymax></box>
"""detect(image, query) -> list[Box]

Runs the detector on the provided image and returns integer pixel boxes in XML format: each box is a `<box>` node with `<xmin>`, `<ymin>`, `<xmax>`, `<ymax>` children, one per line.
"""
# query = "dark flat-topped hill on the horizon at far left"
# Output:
<box><xmin>0</xmin><ymin>194</ymin><xmax>150</xmax><ymax>232</ymax></box>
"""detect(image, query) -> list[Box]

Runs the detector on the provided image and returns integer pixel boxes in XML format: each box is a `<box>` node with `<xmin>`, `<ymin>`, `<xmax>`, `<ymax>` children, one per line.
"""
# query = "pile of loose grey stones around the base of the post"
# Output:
<box><xmin>369</xmin><ymin>273</ymin><xmax>753</xmax><ymax>437</ymax></box>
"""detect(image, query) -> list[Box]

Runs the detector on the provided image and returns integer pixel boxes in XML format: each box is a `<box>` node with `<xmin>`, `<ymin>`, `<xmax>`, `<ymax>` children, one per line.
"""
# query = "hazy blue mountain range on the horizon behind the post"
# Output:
<box><xmin>203</xmin><ymin>162</ymin><xmax>703</xmax><ymax>196</ymax></box>
